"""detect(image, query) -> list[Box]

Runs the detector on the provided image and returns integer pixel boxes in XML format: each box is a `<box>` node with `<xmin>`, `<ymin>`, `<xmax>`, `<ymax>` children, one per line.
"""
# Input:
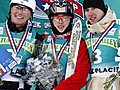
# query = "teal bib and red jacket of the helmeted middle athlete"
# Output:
<box><xmin>43</xmin><ymin>32</ymin><xmax>90</xmax><ymax>90</ymax></box>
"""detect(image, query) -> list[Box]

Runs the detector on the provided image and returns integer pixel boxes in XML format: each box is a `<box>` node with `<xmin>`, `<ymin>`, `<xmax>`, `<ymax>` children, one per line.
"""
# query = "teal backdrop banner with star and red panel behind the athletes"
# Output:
<box><xmin>0</xmin><ymin>0</ymin><xmax>120</xmax><ymax>34</ymax></box>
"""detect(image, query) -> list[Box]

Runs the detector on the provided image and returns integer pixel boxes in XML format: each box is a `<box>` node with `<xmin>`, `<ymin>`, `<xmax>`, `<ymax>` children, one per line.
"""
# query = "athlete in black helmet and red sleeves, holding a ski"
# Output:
<box><xmin>36</xmin><ymin>0</ymin><xmax>90</xmax><ymax>90</ymax></box>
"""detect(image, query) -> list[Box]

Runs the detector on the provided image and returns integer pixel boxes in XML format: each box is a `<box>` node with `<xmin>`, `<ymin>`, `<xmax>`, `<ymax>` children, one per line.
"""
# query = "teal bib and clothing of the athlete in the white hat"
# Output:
<box><xmin>0</xmin><ymin>22</ymin><xmax>36</xmax><ymax>90</ymax></box>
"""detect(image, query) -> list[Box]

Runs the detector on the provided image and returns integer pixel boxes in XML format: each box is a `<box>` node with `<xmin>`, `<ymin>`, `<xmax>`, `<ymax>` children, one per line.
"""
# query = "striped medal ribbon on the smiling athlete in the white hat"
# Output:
<box><xmin>5</xmin><ymin>22</ymin><xmax>28</xmax><ymax>54</ymax></box>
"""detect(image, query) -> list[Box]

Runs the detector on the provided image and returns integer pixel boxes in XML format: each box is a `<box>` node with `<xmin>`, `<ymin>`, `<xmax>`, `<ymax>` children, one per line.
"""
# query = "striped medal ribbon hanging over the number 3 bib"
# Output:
<box><xmin>90</xmin><ymin>21</ymin><xmax>115</xmax><ymax>52</ymax></box>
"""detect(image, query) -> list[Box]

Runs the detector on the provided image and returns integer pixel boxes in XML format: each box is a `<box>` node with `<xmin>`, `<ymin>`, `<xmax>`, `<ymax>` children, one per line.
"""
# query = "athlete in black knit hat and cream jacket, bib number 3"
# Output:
<box><xmin>83</xmin><ymin>0</ymin><xmax>120</xmax><ymax>90</ymax></box>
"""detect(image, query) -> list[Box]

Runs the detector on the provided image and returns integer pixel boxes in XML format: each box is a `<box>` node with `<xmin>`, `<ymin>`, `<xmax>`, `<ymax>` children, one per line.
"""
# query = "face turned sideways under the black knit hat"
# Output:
<box><xmin>85</xmin><ymin>7</ymin><xmax>104</xmax><ymax>24</ymax></box>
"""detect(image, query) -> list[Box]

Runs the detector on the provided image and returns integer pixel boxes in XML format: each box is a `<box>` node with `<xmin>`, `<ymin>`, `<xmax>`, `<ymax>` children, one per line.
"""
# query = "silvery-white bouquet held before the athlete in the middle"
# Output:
<box><xmin>23</xmin><ymin>42</ymin><xmax>63</xmax><ymax>90</ymax></box>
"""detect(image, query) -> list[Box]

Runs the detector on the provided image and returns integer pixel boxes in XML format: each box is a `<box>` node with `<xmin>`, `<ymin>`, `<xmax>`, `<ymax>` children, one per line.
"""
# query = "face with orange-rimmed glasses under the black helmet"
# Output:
<box><xmin>51</xmin><ymin>14</ymin><xmax>71</xmax><ymax>33</ymax></box>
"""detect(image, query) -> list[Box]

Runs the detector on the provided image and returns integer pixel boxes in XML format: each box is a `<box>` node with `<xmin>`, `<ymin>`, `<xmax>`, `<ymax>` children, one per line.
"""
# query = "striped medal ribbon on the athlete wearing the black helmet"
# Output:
<box><xmin>52</xmin><ymin>34</ymin><xmax>70</xmax><ymax>61</ymax></box>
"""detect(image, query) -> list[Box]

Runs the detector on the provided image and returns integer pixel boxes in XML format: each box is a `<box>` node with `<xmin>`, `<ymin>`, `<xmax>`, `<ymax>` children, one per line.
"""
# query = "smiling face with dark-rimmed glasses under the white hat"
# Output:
<box><xmin>11</xmin><ymin>4</ymin><xmax>31</xmax><ymax>27</ymax></box>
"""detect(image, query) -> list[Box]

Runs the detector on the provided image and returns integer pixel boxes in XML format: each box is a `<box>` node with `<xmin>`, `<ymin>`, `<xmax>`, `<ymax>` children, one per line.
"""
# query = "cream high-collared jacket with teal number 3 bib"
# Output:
<box><xmin>83</xmin><ymin>5</ymin><xmax>120</xmax><ymax>90</ymax></box>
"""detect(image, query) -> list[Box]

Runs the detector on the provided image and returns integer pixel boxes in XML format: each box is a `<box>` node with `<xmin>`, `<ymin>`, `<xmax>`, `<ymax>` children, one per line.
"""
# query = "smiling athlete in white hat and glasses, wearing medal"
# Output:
<box><xmin>0</xmin><ymin>0</ymin><xmax>36</xmax><ymax>90</ymax></box>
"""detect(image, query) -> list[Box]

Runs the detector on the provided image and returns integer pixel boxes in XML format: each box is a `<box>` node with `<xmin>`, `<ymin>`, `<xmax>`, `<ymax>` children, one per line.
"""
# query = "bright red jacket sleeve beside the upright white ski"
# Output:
<box><xmin>54</xmin><ymin>39</ymin><xmax>90</xmax><ymax>90</ymax></box>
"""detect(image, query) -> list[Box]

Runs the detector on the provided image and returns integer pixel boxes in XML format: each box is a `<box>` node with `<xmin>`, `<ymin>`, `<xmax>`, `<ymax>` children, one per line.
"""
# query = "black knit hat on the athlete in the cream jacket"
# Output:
<box><xmin>83</xmin><ymin>0</ymin><xmax>107</xmax><ymax>13</ymax></box>
